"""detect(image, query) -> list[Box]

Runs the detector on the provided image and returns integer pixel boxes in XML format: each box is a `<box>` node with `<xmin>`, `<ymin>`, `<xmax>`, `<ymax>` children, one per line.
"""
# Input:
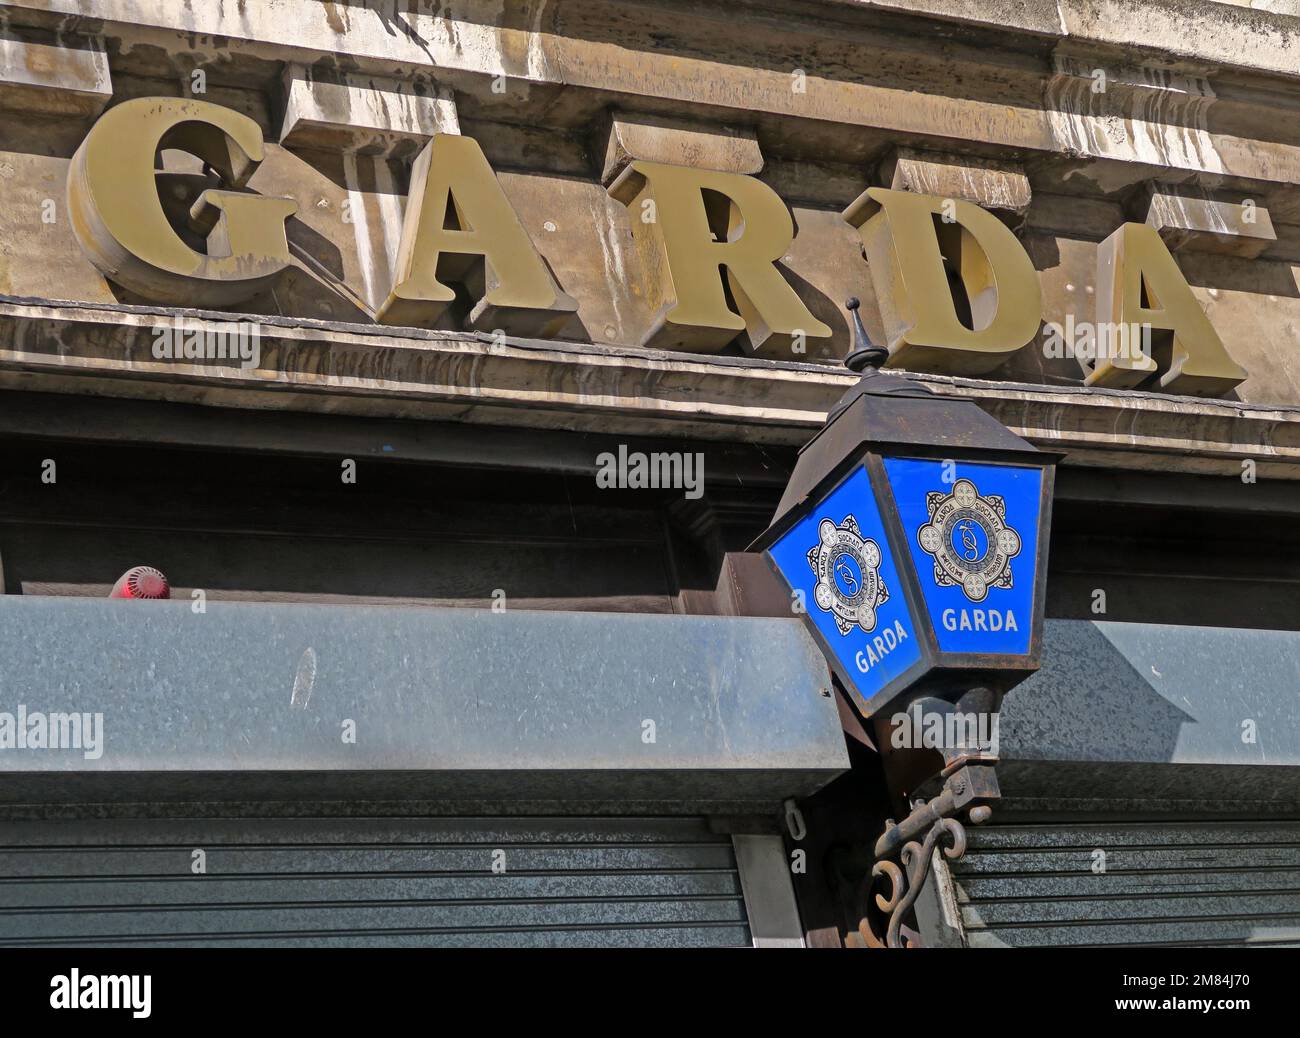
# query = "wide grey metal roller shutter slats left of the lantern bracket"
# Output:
<box><xmin>0</xmin><ymin>818</ymin><xmax>750</xmax><ymax>947</ymax></box>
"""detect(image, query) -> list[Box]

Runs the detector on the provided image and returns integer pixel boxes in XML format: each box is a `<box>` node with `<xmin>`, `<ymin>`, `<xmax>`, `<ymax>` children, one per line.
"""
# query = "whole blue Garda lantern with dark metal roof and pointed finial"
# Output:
<box><xmin>751</xmin><ymin>299</ymin><xmax>1057</xmax><ymax>717</ymax></box>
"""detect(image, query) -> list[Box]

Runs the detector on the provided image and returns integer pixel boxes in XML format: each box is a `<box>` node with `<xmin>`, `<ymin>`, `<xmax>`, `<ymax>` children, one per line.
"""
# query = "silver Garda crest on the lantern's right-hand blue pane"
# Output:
<box><xmin>917</xmin><ymin>480</ymin><xmax>1021</xmax><ymax>602</ymax></box>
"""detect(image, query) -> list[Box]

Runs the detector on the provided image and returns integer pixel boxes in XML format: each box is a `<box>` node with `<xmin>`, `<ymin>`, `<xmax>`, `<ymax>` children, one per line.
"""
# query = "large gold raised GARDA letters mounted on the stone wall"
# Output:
<box><xmin>63</xmin><ymin>98</ymin><xmax>1247</xmax><ymax>395</ymax></box>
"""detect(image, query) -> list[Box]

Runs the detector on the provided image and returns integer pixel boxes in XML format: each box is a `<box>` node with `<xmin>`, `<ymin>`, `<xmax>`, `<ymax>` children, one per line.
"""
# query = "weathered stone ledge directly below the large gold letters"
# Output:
<box><xmin>0</xmin><ymin>297</ymin><xmax>1300</xmax><ymax>479</ymax></box>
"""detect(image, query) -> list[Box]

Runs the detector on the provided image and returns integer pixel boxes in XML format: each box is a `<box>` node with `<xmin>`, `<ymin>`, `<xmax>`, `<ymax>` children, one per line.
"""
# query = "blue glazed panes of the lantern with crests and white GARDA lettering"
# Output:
<box><xmin>766</xmin><ymin>442</ymin><xmax>1052</xmax><ymax>715</ymax></box>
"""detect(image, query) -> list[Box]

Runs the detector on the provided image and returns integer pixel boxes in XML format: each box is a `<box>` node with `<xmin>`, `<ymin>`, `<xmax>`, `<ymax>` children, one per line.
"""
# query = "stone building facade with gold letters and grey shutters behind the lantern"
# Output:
<box><xmin>0</xmin><ymin>0</ymin><xmax>1300</xmax><ymax>946</ymax></box>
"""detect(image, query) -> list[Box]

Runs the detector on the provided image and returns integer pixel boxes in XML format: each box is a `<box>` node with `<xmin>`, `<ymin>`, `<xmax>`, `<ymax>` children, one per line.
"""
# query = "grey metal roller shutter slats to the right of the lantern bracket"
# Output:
<box><xmin>949</xmin><ymin>821</ymin><xmax>1300</xmax><ymax>947</ymax></box>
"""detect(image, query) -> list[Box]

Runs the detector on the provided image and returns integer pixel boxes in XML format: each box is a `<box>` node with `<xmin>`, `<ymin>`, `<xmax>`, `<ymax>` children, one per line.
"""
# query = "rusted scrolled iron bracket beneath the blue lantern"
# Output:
<box><xmin>846</xmin><ymin>756</ymin><xmax>1000</xmax><ymax>948</ymax></box>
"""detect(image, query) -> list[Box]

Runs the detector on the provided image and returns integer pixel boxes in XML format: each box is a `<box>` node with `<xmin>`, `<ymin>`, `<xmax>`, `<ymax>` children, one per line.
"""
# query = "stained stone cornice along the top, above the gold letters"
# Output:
<box><xmin>10</xmin><ymin>0</ymin><xmax>1300</xmax><ymax>197</ymax></box>
